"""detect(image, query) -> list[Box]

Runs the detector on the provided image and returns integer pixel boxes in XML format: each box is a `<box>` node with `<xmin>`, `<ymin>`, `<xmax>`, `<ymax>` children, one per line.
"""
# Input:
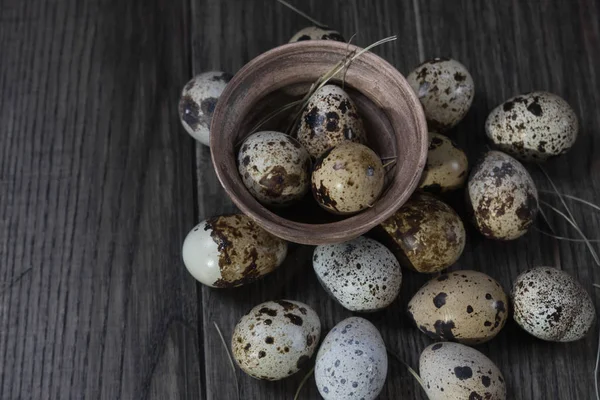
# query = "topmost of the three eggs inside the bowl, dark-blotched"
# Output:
<box><xmin>297</xmin><ymin>85</ymin><xmax>366</xmax><ymax>158</ymax></box>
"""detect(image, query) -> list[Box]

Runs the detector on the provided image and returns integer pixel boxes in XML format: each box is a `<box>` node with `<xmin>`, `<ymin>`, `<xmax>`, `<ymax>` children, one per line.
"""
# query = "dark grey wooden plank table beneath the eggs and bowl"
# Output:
<box><xmin>0</xmin><ymin>0</ymin><xmax>600</xmax><ymax>400</ymax></box>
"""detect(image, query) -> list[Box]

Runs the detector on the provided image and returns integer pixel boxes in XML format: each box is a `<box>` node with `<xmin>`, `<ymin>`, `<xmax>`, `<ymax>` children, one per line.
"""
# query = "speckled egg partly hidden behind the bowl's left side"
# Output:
<box><xmin>179</xmin><ymin>71</ymin><xmax>232</xmax><ymax>146</ymax></box>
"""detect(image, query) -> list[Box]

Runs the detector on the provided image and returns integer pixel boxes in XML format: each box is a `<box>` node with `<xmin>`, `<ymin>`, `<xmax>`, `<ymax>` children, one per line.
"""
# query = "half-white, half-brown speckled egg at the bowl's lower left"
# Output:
<box><xmin>182</xmin><ymin>214</ymin><xmax>287</xmax><ymax>288</ymax></box>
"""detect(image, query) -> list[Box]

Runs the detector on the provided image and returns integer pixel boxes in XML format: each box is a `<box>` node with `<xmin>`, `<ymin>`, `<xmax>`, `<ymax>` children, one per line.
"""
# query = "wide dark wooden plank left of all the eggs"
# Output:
<box><xmin>0</xmin><ymin>0</ymin><xmax>201</xmax><ymax>399</ymax></box>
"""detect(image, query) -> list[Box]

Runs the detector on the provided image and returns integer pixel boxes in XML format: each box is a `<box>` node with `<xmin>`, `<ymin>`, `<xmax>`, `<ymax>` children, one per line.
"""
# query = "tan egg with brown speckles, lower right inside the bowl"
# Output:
<box><xmin>312</xmin><ymin>142</ymin><xmax>385</xmax><ymax>214</ymax></box>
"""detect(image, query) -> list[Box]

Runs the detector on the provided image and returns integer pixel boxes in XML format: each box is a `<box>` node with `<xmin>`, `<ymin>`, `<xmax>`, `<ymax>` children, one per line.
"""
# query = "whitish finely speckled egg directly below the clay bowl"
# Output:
<box><xmin>313</xmin><ymin>236</ymin><xmax>402</xmax><ymax>312</ymax></box>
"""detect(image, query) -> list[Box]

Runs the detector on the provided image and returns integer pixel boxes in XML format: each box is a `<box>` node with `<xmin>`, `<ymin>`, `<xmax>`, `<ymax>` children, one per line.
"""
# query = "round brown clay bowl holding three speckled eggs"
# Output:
<box><xmin>210</xmin><ymin>40</ymin><xmax>428</xmax><ymax>245</ymax></box>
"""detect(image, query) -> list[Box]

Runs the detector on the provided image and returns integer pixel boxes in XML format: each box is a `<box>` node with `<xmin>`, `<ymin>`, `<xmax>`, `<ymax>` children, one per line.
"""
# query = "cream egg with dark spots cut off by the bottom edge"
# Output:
<box><xmin>419</xmin><ymin>343</ymin><xmax>506</xmax><ymax>400</ymax></box>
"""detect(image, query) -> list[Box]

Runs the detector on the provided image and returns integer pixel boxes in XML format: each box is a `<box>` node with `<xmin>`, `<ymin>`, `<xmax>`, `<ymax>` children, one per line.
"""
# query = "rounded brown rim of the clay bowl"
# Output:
<box><xmin>210</xmin><ymin>40</ymin><xmax>429</xmax><ymax>245</ymax></box>
